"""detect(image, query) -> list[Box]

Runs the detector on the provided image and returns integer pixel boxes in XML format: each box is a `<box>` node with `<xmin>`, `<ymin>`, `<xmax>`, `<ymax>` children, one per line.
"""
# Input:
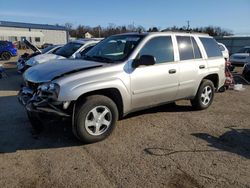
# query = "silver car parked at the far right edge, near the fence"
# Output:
<box><xmin>229</xmin><ymin>46</ymin><xmax>250</xmax><ymax>66</ymax></box>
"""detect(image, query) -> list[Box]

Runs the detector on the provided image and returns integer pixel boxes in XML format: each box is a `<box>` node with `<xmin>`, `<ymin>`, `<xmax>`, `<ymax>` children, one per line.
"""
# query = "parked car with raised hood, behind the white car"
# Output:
<box><xmin>17</xmin><ymin>40</ymin><xmax>62</xmax><ymax>73</ymax></box>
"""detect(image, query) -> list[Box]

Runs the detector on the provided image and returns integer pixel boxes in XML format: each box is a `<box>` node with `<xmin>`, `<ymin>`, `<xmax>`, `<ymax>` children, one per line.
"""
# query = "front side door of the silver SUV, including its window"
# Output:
<box><xmin>131</xmin><ymin>36</ymin><xmax>179</xmax><ymax>109</ymax></box>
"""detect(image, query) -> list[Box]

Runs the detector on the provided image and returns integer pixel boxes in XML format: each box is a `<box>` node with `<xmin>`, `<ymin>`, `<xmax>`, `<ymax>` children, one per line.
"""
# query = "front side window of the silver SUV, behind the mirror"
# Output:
<box><xmin>139</xmin><ymin>36</ymin><xmax>174</xmax><ymax>63</ymax></box>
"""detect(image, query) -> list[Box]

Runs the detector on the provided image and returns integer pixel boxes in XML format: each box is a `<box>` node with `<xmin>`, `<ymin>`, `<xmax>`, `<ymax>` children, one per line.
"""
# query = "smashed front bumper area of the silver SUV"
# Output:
<box><xmin>18</xmin><ymin>87</ymin><xmax>71</xmax><ymax>118</ymax></box>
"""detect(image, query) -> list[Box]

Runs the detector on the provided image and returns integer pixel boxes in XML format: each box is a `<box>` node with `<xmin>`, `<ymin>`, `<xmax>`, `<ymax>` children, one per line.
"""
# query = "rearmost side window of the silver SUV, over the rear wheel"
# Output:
<box><xmin>200</xmin><ymin>37</ymin><xmax>222</xmax><ymax>57</ymax></box>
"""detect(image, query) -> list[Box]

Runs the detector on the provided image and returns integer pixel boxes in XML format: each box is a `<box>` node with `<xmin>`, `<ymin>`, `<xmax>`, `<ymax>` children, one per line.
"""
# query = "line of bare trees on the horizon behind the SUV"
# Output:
<box><xmin>65</xmin><ymin>23</ymin><xmax>233</xmax><ymax>38</ymax></box>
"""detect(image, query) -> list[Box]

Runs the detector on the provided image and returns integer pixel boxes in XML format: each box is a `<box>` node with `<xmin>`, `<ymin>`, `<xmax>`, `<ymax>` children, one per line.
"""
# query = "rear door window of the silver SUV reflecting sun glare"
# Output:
<box><xmin>176</xmin><ymin>36</ymin><xmax>201</xmax><ymax>60</ymax></box>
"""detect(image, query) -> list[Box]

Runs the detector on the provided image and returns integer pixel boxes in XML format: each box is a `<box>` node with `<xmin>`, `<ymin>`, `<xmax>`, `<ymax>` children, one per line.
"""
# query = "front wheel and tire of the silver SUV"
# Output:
<box><xmin>73</xmin><ymin>95</ymin><xmax>118</xmax><ymax>144</ymax></box>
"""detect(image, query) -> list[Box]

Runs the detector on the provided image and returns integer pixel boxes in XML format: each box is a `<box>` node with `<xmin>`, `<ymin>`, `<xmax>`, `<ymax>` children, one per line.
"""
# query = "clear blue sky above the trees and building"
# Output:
<box><xmin>0</xmin><ymin>0</ymin><xmax>250</xmax><ymax>35</ymax></box>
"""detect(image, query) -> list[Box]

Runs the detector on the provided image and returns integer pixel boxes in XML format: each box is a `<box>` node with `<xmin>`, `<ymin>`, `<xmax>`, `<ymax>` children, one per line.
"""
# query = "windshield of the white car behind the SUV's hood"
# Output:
<box><xmin>55</xmin><ymin>42</ymin><xmax>83</xmax><ymax>58</ymax></box>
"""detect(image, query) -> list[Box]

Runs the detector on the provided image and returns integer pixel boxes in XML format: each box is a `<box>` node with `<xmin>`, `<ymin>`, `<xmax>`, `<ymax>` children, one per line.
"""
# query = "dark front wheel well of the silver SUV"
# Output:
<box><xmin>76</xmin><ymin>88</ymin><xmax>123</xmax><ymax>119</ymax></box>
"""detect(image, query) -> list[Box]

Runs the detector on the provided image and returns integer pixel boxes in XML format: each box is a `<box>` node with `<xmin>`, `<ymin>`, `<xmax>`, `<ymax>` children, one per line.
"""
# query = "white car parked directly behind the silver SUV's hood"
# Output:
<box><xmin>25</xmin><ymin>39</ymin><xmax>101</xmax><ymax>69</ymax></box>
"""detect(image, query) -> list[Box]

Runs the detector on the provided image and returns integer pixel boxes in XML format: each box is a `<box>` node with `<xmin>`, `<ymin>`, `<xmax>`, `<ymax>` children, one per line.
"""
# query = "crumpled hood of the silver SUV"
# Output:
<box><xmin>24</xmin><ymin>59</ymin><xmax>103</xmax><ymax>83</ymax></box>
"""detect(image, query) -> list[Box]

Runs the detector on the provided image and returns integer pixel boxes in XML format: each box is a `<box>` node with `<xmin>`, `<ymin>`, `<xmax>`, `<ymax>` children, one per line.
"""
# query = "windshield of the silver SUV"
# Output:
<box><xmin>83</xmin><ymin>35</ymin><xmax>144</xmax><ymax>63</ymax></box>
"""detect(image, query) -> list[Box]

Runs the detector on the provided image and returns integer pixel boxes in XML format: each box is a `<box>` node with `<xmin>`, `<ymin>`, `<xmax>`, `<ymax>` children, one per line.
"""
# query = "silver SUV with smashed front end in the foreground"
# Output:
<box><xmin>19</xmin><ymin>32</ymin><xmax>225</xmax><ymax>143</ymax></box>
